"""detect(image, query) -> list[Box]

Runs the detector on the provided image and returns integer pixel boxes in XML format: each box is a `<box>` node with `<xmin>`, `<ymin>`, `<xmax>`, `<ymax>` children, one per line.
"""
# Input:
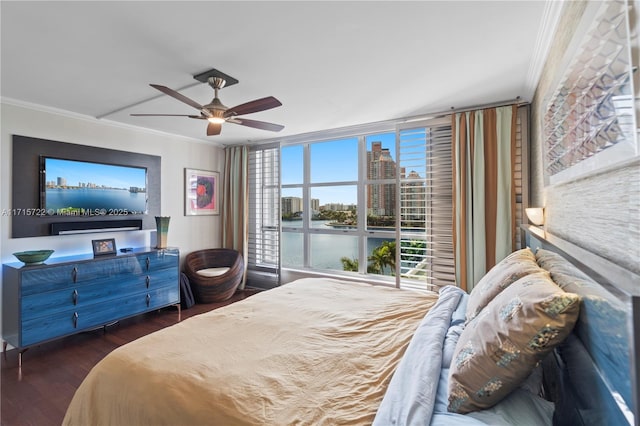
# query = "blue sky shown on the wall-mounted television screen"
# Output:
<box><xmin>46</xmin><ymin>158</ymin><xmax>147</xmax><ymax>189</ymax></box>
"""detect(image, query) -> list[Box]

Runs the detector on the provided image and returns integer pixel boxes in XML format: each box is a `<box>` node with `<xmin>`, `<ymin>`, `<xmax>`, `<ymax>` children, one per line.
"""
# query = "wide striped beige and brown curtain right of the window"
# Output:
<box><xmin>452</xmin><ymin>105</ymin><xmax>517</xmax><ymax>292</ymax></box>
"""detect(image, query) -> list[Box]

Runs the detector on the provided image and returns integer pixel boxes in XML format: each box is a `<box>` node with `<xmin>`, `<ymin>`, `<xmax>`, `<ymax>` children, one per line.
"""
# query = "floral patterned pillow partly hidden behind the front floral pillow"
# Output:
<box><xmin>466</xmin><ymin>247</ymin><xmax>543</xmax><ymax>322</ymax></box>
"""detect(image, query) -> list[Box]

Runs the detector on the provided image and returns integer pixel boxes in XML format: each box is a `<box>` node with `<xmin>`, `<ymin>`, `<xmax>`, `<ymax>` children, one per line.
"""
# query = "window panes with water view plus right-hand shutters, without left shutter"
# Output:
<box><xmin>281</xmin><ymin>120</ymin><xmax>454</xmax><ymax>289</ymax></box>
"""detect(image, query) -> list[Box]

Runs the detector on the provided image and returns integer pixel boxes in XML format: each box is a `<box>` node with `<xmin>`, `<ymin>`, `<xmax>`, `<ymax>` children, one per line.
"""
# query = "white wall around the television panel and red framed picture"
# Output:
<box><xmin>0</xmin><ymin>100</ymin><xmax>224</xmax><ymax>263</ymax></box>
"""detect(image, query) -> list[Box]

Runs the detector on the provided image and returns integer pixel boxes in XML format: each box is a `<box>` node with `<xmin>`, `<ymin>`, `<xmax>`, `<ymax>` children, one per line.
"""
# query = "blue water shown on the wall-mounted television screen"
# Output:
<box><xmin>46</xmin><ymin>188</ymin><xmax>147</xmax><ymax>215</ymax></box>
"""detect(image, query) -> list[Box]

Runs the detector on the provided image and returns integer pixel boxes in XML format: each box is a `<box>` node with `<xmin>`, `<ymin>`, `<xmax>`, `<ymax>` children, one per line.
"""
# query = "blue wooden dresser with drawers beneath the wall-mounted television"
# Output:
<box><xmin>2</xmin><ymin>248</ymin><xmax>180</xmax><ymax>358</ymax></box>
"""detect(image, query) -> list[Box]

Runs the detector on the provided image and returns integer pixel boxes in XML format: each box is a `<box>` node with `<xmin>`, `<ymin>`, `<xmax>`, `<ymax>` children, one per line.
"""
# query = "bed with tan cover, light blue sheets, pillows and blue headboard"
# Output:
<box><xmin>63</xmin><ymin>232</ymin><xmax>639</xmax><ymax>426</ymax></box>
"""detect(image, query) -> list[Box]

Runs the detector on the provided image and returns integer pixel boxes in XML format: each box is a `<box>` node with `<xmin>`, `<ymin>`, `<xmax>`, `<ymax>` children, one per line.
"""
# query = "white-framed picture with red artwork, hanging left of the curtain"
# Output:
<box><xmin>184</xmin><ymin>168</ymin><xmax>220</xmax><ymax>216</ymax></box>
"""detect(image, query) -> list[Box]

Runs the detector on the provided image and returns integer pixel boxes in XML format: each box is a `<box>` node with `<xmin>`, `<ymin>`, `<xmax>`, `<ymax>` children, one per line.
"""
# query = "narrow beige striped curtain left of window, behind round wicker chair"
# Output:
<box><xmin>222</xmin><ymin>146</ymin><xmax>249</xmax><ymax>289</ymax></box>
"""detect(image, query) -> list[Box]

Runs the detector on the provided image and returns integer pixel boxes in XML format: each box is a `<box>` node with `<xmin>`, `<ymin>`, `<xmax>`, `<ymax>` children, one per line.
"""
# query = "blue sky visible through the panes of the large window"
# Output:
<box><xmin>282</xmin><ymin>132</ymin><xmax>396</xmax><ymax>205</ymax></box>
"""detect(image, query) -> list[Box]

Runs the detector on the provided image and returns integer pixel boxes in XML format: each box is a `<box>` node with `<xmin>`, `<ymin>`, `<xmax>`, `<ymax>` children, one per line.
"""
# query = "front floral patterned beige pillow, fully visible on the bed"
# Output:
<box><xmin>448</xmin><ymin>272</ymin><xmax>580</xmax><ymax>413</ymax></box>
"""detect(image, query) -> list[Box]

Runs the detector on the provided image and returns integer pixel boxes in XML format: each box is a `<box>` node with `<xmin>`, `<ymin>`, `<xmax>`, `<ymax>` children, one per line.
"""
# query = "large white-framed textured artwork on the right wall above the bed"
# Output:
<box><xmin>542</xmin><ymin>1</ymin><xmax>640</xmax><ymax>185</ymax></box>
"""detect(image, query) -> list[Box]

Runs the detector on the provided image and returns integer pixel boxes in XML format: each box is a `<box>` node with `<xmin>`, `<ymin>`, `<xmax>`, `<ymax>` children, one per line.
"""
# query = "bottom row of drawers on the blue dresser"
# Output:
<box><xmin>20</xmin><ymin>287</ymin><xmax>180</xmax><ymax>346</ymax></box>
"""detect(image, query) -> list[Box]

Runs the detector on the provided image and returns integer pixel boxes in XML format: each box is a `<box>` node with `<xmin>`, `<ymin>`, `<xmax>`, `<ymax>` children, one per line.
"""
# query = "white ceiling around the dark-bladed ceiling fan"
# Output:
<box><xmin>0</xmin><ymin>0</ymin><xmax>550</xmax><ymax>144</ymax></box>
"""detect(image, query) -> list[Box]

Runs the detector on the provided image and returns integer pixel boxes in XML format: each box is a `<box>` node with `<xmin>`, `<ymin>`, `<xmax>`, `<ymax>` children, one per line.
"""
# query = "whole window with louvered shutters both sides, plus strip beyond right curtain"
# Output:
<box><xmin>249</xmin><ymin>108</ymin><xmax>528</xmax><ymax>290</ymax></box>
